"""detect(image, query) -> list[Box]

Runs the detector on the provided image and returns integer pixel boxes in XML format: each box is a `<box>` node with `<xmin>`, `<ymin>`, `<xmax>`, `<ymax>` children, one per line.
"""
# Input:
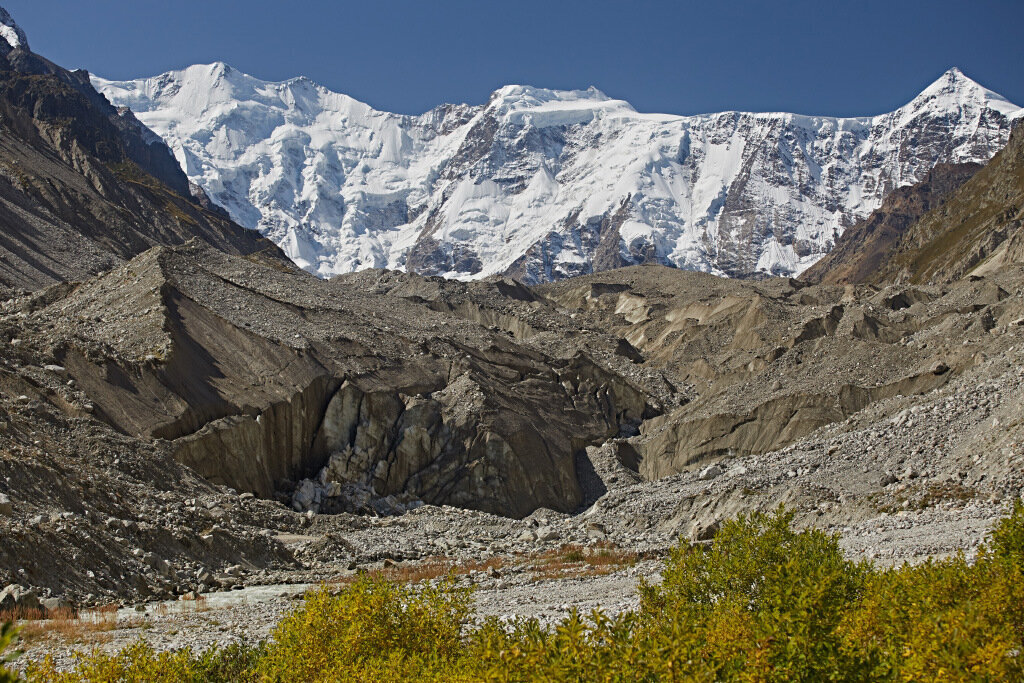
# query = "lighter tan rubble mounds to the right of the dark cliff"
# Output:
<box><xmin>534</xmin><ymin>266</ymin><xmax>1016</xmax><ymax>478</ymax></box>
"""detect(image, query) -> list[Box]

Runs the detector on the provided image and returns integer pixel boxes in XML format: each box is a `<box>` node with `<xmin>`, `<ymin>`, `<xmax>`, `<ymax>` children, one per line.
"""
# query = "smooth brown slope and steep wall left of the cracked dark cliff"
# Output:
<box><xmin>63</xmin><ymin>292</ymin><xmax>341</xmax><ymax>496</ymax></box>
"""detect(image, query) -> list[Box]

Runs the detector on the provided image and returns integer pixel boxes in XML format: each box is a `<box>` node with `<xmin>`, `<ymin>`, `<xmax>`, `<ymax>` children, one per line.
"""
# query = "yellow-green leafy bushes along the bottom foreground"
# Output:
<box><xmin>9</xmin><ymin>506</ymin><xmax>1024</xmax><ymax>682</ymax></box>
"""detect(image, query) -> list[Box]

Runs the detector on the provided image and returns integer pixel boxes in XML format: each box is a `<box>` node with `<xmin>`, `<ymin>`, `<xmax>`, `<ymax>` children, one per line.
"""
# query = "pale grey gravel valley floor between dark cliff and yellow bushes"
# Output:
<box><xmin>12</xmin><ymin>335</ymin><xmax>1024</xmax><ymax>667</ymax></box>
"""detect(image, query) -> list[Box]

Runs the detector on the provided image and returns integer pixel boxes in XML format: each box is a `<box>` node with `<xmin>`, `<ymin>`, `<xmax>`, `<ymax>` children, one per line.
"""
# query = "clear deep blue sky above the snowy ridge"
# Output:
<box><xmin>8</xmin><ymin>0</ymin><xmax>1024</xmax><ymax>116</ymax></box>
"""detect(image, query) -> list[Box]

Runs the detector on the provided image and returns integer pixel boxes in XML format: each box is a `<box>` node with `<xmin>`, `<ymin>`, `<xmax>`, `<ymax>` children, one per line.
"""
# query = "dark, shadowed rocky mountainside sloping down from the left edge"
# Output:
<box><xmin>0</xmin><ymin>38</ymin><xmax>291</xmax><ymax>289</ymax></box>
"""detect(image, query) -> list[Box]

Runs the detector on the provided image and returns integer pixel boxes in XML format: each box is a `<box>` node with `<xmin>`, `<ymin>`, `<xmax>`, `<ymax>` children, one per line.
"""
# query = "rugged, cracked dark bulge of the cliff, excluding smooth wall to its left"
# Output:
<box><xmin>299</xmin><ymin>348</ymin><xmax>647</xmax><ymax>517</ymax></box>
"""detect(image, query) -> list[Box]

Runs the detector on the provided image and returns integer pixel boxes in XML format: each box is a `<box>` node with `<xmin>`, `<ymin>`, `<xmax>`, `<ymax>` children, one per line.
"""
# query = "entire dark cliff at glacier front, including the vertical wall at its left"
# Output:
<box><xmin>167</xmin><ymin>344</ymin><xmax>646</xmax><ymax>516</ymax></box>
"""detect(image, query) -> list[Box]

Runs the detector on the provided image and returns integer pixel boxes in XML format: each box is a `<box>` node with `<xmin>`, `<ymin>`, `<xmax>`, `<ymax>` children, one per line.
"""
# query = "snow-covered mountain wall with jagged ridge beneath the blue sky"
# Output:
<box><xmin>93</xmin><ymin>63</ymin><xmax>1022</xmax><ymax>282</ymax></box>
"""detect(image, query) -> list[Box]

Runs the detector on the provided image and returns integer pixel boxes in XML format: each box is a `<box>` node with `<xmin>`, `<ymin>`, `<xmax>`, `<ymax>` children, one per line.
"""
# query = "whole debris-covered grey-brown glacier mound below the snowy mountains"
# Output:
<box><xmin>24</xmin><ymin>228</ymin><xmax>1019</xmax><ymax>517</ymax></box>
